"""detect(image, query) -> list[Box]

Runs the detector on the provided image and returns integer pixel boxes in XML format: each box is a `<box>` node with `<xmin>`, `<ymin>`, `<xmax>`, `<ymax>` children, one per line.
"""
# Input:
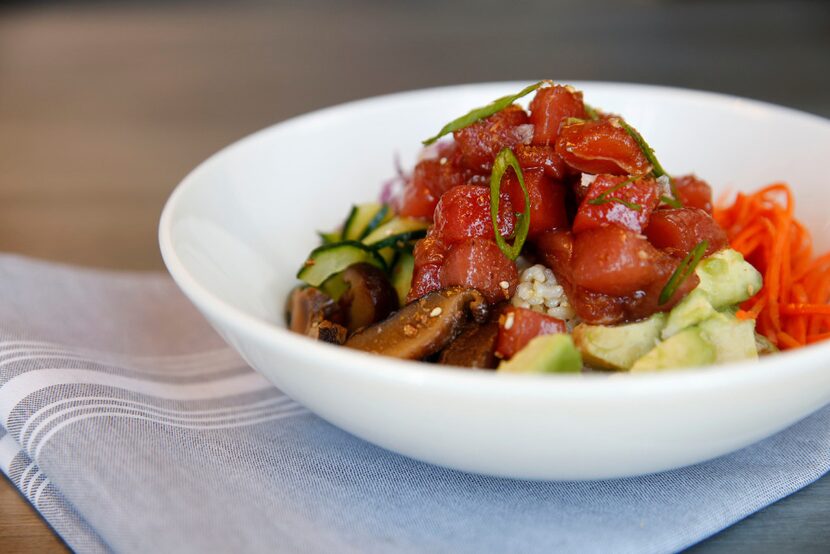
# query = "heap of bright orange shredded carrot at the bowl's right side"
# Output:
<box><xmin>713</xmin><ymin>183</ymin><xmax>830</xmax><ymax>349</ymax></box>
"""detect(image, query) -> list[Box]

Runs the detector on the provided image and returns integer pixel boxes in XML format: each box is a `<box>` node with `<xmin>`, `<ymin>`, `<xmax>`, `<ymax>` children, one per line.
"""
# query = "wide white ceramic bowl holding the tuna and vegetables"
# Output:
<box><xmin>160</xmin><ymin>83</ymin><xmax>830</xmax><ymax>479</ymax></box>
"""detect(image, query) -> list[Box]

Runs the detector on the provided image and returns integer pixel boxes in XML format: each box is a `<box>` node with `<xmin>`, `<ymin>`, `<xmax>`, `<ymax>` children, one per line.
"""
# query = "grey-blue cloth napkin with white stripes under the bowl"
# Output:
<box><xmin>0</xmin><ymin>252</ymin><xmax>830</xmax><ymax>553</ymax></box>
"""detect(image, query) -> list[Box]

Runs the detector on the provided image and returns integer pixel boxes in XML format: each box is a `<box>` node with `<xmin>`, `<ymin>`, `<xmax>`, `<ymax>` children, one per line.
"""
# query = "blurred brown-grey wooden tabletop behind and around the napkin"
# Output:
<box><xmin>0</xmin><ymin>0</ymin><xmax>830</xmax><ymax>552</ymax></box>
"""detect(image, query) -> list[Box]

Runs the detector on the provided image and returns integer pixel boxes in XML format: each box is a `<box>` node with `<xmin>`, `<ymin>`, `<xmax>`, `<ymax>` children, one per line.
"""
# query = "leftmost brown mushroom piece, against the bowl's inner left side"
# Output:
<box><xmin>287</xmin><ymin>287</ymin><xmax>346</xmax><ymax>344</ymax></box>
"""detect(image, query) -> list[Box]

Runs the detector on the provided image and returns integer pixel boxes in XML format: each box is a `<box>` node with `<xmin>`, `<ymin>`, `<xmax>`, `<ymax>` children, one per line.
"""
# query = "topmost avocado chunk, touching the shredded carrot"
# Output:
<box><xmin>695</xmin><ymin>248</ymin><xmax>762</xmax><ymax>308</ymax></box>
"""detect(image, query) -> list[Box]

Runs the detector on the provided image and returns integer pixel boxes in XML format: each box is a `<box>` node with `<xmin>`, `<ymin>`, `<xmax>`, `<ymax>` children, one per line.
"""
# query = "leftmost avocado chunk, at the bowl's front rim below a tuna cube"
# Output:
<box><xmin>498</xmin><ymin>333</ymin><xmax>582</xmax><ymax>373</ymax></box>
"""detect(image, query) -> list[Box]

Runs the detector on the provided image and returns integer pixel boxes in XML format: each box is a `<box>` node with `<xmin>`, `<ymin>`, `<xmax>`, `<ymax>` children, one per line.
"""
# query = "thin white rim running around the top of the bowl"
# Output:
<box><xmin>159</xmin><ymin>80</ymin><xmax>830</xmax><ymax>399</ymax></box>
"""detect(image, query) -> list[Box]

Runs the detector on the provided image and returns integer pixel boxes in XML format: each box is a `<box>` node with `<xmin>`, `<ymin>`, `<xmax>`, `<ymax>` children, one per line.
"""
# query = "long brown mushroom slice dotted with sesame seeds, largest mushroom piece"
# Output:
<box><xmin>346</xmin><ymin>287</ymin><xmax>488</xmax><ymax>360</ymax></box>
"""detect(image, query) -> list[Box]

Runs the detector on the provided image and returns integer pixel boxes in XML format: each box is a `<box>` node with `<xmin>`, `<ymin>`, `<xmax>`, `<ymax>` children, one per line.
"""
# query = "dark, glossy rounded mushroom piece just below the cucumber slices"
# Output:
<box><xmin>340</xmin><ymin>263</ymin><xmax>398</xmax><ymax>333</ymax></box>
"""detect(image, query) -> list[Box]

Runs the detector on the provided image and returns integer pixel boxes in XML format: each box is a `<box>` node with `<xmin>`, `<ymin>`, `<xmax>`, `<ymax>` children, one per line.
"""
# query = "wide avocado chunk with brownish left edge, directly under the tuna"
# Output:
<box><xmin>573</xmin><ymin>313</ymin><xmax>666</xmax><ymax>370</ymax></box>
